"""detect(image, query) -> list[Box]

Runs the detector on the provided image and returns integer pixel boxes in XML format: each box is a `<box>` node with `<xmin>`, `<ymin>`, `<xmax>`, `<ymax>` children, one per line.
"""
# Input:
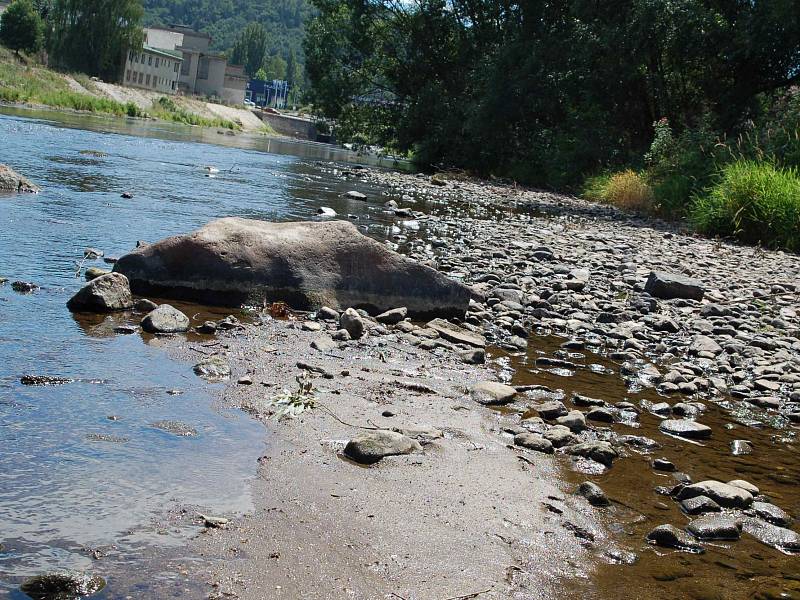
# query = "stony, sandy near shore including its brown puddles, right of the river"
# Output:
<box><xmin>153</xmin><ymin>170</ymin><xmax>800</xmax><ymax>598</ymax></box>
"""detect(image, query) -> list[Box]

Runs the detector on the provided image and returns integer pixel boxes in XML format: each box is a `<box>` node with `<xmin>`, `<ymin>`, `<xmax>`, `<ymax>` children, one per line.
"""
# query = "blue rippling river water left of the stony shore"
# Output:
<box><xmin>0</xmin><ymin>109</ymin><xmax>418</xmax><ymax>596</ymax></box>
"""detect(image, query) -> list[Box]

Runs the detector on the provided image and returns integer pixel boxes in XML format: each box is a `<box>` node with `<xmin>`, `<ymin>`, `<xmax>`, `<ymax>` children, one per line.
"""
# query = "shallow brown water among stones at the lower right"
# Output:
<box><xmin>500</xmin><ymin>336</ymin><xmax>800</xmax><ymax>600</ymax></box>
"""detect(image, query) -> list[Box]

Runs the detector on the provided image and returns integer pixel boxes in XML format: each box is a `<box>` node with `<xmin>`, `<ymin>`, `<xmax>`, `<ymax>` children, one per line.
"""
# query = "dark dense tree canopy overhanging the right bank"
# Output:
<box><xmin>305</xmin><ymin>0</ymin><xmax>800</xmax><ymax>186</ymax></box>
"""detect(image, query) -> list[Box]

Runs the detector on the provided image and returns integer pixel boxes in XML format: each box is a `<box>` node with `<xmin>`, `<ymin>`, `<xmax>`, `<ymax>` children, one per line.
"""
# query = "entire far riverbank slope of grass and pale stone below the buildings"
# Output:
<box><xmin>0</xmin><ymin>47</ymin><xmax>274</xmax><ymax>133</ymax></box>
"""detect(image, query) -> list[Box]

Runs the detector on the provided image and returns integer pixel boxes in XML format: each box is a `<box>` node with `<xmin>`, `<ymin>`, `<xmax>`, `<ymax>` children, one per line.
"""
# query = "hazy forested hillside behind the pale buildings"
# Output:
<box><xmin>142</xmin><ymin>0</ymin><xmax>311</xmax><ymax>61</ymax></box>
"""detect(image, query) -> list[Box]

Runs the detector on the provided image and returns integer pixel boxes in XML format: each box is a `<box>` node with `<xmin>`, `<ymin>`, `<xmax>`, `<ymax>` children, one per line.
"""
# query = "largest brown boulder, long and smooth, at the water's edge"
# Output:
<box><xmin>114</xmin><ymin>218</ymin><xmax>470</xmax><ymax>316</ymax></box>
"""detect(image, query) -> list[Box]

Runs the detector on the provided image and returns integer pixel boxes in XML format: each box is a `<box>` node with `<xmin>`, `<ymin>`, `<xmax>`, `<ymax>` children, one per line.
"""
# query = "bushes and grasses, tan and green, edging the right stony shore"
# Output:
<box><xmin>582</xmin><ymin>88</ymin><xmax>800</xmax><ymax>252</ymax></box>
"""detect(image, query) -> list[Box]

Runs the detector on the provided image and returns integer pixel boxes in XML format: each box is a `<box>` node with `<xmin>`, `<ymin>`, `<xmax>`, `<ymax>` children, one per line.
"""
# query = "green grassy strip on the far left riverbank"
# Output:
<box><xmin>0</xmin><ymin>46</ymin><xmax>239</xmax><ymax>130</ymax></box>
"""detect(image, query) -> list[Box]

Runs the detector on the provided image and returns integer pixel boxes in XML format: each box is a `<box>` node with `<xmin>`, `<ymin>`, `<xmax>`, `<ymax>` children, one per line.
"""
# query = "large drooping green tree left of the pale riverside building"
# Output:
<box><xmin>50</xmin><ymin>0</ymin><xmax>144</xmax><ymax>81</ymax></box>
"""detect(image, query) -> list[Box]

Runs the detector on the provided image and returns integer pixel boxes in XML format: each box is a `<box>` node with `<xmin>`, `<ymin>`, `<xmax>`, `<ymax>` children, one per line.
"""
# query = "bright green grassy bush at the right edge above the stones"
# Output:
<box><xmin>690</xmin><ymin>160</ymin><xmax>800</xmax><ymax>251</ymax></box>
